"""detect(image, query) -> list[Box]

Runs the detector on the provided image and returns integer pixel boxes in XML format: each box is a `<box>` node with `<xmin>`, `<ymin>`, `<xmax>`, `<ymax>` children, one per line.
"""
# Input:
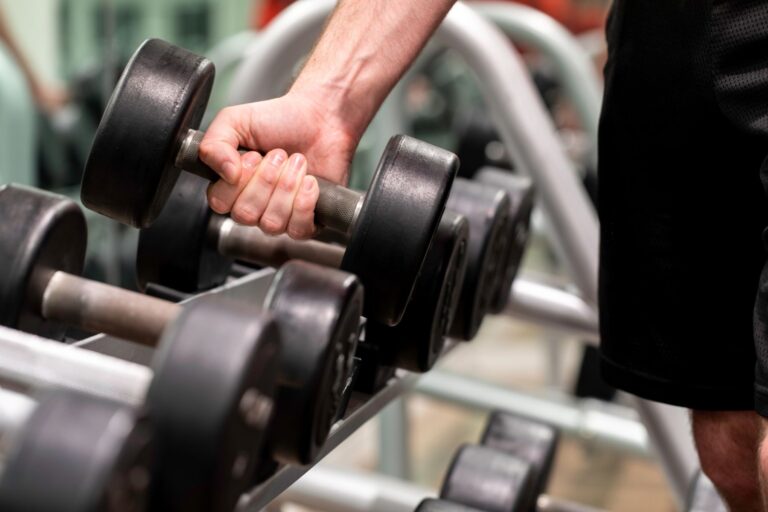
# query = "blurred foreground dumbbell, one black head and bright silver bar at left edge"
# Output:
<box><xmin>1</xmin><ymin>301</ymin><xmax>280</xmax><ymax>512</ymax></box>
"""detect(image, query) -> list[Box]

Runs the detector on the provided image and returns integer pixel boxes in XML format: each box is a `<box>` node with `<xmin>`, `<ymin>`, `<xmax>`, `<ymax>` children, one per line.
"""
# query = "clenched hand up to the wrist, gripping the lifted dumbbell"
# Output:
<box><xmin>200</xmin><ymin>93</ymin><xmax>358</xmax><ymax>239</ymax></box>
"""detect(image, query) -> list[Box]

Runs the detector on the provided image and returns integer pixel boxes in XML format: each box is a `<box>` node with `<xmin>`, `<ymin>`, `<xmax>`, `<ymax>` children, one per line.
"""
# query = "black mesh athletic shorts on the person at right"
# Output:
<box><xmin>598</xmin><ymin>0</ymin><xmax>768</xmax><ymax>416</ymax></box>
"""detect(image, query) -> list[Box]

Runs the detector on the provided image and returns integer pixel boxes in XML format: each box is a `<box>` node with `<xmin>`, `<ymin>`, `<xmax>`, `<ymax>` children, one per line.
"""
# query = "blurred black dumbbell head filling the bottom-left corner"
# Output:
<box><xmin>0</xmin><ymin>389</ymin><xmax>153</xmax><ymax>512</ymax></box>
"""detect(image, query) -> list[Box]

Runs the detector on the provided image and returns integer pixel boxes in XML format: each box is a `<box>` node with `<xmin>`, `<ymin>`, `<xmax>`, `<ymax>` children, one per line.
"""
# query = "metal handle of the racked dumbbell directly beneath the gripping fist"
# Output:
<box><xmin>209</xmin><ymin>215</ymin><xmax>344</xmax><ymax>268</ymax></box>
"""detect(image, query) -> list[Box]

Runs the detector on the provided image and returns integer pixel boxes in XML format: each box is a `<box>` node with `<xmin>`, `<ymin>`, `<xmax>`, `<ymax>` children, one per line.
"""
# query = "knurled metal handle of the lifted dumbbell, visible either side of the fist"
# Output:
<box><xmin>175</xmin><ymin>130</ymin><xmax>365</xmax><ymax>236</ymax></box>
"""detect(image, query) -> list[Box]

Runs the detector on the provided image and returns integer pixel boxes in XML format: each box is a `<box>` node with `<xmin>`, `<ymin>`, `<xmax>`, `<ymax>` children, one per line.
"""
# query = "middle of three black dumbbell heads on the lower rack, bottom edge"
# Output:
<box><xmin>440</xmin><ymin>445</ymin><xmax>532</xmax><ymax>512</ymax></box>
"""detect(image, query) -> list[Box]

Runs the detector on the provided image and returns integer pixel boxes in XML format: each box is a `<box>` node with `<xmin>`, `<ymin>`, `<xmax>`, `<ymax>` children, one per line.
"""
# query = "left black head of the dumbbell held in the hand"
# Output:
<box><xmin>81</xmin><ymin>39</ymin><xmax>214</xmax><ymax>227</ymax></box>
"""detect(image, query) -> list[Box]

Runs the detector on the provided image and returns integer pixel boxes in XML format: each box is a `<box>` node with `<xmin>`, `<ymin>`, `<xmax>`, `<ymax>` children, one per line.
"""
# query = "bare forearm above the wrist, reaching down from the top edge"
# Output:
<box><xmin>291</xmin><ymin>0</ymin><xmax>455</xmax><ymax>138</ymax></box>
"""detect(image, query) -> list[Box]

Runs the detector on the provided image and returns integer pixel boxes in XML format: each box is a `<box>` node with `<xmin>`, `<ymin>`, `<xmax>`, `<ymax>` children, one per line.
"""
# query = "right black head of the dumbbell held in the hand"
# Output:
<box><xmin>341</xmin><ymin>135</ymin><xmax>459</xmax><ymax>326</ymax></box>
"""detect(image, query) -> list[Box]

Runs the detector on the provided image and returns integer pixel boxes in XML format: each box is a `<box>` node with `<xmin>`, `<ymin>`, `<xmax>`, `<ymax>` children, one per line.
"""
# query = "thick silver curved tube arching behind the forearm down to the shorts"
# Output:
<box><xmin>229</xmin><ymin>0</ymin><xmax>598</xmax><ymax>304</ymax></box>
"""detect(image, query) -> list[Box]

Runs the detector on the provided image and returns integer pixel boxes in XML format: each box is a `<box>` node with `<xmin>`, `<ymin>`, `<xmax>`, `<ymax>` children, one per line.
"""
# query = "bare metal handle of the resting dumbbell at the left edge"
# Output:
<box><xmin>39</xmin><ymin>272</ymin><xmax>181</xmax><ymax>347</ymax></box>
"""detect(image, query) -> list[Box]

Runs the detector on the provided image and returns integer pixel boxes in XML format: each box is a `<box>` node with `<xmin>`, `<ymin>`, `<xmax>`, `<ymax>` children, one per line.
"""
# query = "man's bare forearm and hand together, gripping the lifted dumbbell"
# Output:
<box><xmin>200</xmin><ymin>0</ymin><xmax>455</xmax><ymax>238</ymax></box>
